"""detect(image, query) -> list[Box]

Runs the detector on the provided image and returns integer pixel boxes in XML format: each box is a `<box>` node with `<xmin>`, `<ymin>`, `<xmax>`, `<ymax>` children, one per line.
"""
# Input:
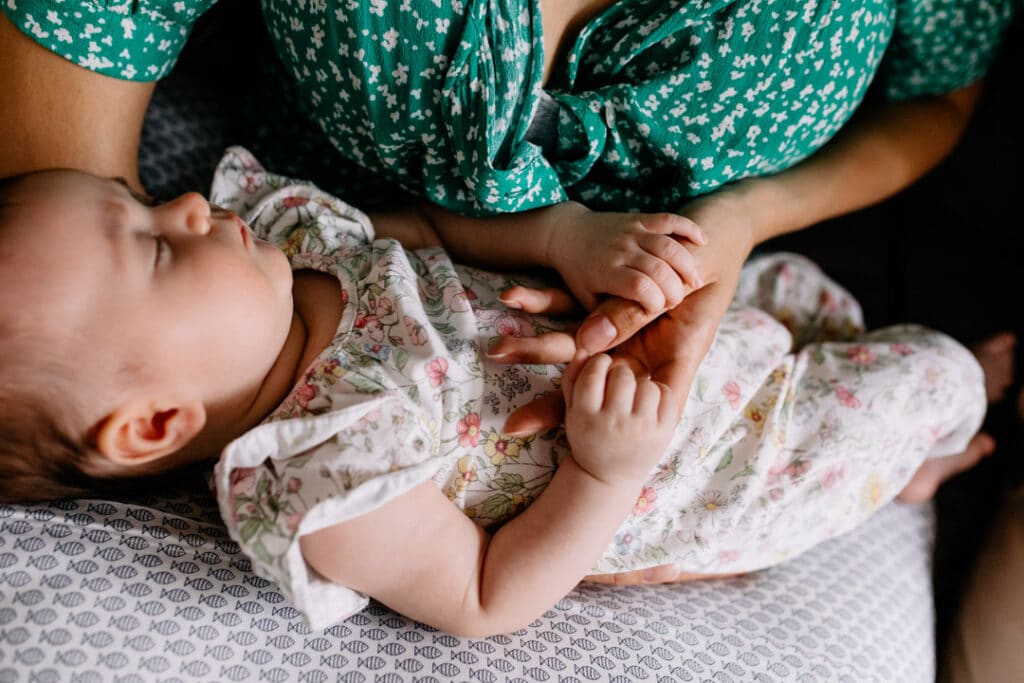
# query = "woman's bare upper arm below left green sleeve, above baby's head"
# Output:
<box><xmin>0</xmin><ymin>11</ymin><xmax>154</xmax><ymax>189</ymax></box>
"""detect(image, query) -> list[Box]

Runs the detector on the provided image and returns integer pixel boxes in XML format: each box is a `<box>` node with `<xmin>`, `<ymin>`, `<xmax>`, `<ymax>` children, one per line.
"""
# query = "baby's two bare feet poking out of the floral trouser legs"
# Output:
<box><xmin>896</xmin><ymin>333</ymin><xmax>1017</xmax><ymax>503</ymax></box>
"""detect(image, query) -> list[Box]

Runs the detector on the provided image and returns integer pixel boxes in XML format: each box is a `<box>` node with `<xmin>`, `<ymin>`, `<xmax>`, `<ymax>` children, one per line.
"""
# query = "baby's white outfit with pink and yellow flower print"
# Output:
<box><xmin>211</xmin><ymin>147</ymin><xmax>985</xmax><ymax>627</ymax></box>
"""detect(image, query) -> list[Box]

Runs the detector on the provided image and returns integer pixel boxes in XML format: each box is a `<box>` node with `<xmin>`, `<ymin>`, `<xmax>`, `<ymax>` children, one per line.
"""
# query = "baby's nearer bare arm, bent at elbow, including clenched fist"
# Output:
<box><xmin>300</xmin><ymin>355</ymin><xmax>678</xmax><ymax>637</ymax></box>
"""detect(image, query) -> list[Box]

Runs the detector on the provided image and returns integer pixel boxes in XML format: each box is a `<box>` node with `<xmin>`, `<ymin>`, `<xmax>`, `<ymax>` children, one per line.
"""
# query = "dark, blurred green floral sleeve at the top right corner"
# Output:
<box><xmin>881</xmin><ymin>0</ymin><xmax>1019</xmax><ymax>99</ymax></box>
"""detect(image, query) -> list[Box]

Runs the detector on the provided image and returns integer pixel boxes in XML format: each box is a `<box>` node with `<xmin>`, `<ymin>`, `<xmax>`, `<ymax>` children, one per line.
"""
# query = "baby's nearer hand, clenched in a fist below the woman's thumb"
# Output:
<box><xmin>562</xmin><ymin>353</ymin><xmax>678</xmax><ymax>483</ymax></box>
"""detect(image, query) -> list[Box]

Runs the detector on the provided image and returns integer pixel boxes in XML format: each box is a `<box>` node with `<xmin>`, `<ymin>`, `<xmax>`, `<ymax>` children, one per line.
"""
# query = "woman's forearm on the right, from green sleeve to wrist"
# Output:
<box><xmin>726</xmin><ymin>82</ymin><xmax>981</xmax><ymax>244</ymax></box>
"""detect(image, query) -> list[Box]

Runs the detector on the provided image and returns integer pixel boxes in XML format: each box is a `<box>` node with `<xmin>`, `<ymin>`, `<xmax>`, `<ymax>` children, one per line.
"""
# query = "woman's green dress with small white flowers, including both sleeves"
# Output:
<box><xmin>4</xmin><ymin>0</ymin><xmax>1019</xmax><ymax>214</ymax></box>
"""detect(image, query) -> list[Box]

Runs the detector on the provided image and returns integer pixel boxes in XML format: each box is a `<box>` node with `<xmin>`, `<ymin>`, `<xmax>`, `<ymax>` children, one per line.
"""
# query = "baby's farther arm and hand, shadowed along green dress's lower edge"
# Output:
<box><xmin>371</xmin><ymin>202</ymin><xmax>705</xmax><ymax>315</ymax></box>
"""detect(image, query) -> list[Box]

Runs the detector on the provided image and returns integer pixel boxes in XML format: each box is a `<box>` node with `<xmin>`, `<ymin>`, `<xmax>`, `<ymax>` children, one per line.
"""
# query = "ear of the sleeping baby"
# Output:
<box><xmin>95</xmin><ymin>400</ymin><xmax>206</xmax><ymax>466</ymax></box>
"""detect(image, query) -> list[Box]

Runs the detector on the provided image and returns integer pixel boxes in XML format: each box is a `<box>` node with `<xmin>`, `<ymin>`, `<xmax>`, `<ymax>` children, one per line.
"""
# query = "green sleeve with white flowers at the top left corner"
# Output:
<box><xmin>0</xmin><ymin>0</ymin><xmax>216</xmax><ymax>81</ymax></box>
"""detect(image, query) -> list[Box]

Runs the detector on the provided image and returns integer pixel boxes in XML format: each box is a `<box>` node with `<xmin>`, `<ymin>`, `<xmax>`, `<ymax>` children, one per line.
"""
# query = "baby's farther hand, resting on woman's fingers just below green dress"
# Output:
<box><xmin>548</xmin><ymin>202</ymin><xmax>707</xmax><ymax>316</ymax></box>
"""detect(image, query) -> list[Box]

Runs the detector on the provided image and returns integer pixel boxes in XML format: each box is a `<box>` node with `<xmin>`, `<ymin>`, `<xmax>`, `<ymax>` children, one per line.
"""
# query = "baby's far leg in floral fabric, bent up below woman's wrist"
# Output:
<box><xmin>735</xmin><ymin>252</ymin><xmax>864</xmax><ymax>349</ymax></box>
